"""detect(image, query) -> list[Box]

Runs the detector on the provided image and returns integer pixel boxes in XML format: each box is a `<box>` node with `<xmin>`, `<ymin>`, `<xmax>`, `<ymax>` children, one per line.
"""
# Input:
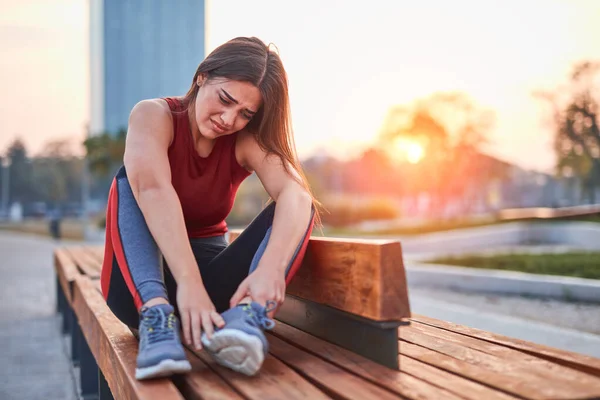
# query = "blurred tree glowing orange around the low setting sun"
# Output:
<box><xmin>379</xmin><ymin>93</ymin><xmax>505</xmax><ymax>216</ymax></box>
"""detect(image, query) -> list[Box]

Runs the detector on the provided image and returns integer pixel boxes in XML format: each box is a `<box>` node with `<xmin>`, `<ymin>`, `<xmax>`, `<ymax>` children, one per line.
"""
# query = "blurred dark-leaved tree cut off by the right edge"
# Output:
<box><xmin>534</xmin><ymin>61</ymin><xmax>600</xmax><ymax>203</ymax></box>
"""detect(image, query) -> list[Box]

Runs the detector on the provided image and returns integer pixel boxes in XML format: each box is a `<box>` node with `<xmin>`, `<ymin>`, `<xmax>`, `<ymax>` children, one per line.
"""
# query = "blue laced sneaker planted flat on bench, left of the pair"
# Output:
<box><xmin>135</xmin><ymin>304</ymin><xmax>192</xmax><ymax>380</ymax></box>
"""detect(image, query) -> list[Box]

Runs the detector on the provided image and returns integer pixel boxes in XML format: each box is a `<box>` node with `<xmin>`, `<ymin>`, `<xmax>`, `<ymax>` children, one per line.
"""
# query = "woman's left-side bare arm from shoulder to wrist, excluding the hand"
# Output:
<box><xmin>124</xmin><ymin>100</ymin><xmax>201</xmax><ymax>283</ymax></box>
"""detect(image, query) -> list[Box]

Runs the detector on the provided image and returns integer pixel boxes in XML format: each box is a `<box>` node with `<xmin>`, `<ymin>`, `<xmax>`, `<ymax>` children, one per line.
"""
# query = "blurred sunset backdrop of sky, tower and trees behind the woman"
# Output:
<box><xmin>0</xmin><ymin>0</ymin><xmax>600</xmax><ymax>238</ymax></box>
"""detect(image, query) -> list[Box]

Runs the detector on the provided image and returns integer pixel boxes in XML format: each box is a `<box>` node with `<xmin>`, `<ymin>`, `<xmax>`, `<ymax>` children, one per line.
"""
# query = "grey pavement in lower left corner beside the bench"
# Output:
<box><xmin>0</xmin><ymin>232</ymin><xmax>77</xmax><ymax>400</ymax></box>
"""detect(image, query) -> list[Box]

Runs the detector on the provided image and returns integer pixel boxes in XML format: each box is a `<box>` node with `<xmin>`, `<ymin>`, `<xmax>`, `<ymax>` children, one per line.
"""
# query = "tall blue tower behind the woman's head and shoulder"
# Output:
<box><xmin>90</xmin><ymin>0</ymin><xmax>206</xmax><ymax>135</ymax></box>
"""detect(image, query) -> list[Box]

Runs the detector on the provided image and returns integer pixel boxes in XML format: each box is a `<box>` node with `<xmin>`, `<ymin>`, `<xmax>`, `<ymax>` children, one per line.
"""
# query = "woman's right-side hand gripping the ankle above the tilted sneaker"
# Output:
<box><xmin>229</xmin><ymin>266</ymin><xmax>285</xmax><ymax>314</ymax></box>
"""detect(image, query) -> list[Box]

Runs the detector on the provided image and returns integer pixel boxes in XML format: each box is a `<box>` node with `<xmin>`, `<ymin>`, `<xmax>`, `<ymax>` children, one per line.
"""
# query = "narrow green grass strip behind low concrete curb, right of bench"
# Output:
<box><xmin>428</xmin><ymin>252</ymin><xmax>600</xmax><ymax>279</ymax></box>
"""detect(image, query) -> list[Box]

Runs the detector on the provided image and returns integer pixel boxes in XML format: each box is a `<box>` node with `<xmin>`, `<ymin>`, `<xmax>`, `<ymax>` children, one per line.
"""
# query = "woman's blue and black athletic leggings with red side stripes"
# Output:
<box><xmin>101</xmin><ymin>167</ymin><xmax>314</xmax><ymax>328</ymax></box>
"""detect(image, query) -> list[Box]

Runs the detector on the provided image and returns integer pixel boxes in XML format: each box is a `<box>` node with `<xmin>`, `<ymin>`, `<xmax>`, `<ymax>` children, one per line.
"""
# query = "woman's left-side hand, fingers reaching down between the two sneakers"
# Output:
<box><xmin>177</xmin><ymin>280</ymin><xmax>225</xmax><ymax>350</ymax></box>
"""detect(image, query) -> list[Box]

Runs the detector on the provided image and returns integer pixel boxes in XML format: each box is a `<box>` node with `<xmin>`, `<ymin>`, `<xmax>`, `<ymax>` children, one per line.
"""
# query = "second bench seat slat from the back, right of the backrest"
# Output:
<box><xmin>403</xmin><ymin>322</ymin><xmax>600</xmax><ymax>395</ymax></box>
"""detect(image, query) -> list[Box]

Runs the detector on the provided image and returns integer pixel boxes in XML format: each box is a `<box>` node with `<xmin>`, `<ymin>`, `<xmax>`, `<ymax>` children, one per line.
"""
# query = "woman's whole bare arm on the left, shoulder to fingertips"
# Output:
<box><xmin>125</xmin><ymin>100</ymin><xmax>224</xmax><ymax>349</ymax></box>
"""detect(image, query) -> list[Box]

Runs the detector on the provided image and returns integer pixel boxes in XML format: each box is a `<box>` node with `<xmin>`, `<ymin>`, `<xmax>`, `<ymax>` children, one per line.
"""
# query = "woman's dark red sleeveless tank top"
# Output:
<box><xmin>165</xmin><ymin>97</ymin><xmax>250</xmax><ymax>238</ymax></box>
